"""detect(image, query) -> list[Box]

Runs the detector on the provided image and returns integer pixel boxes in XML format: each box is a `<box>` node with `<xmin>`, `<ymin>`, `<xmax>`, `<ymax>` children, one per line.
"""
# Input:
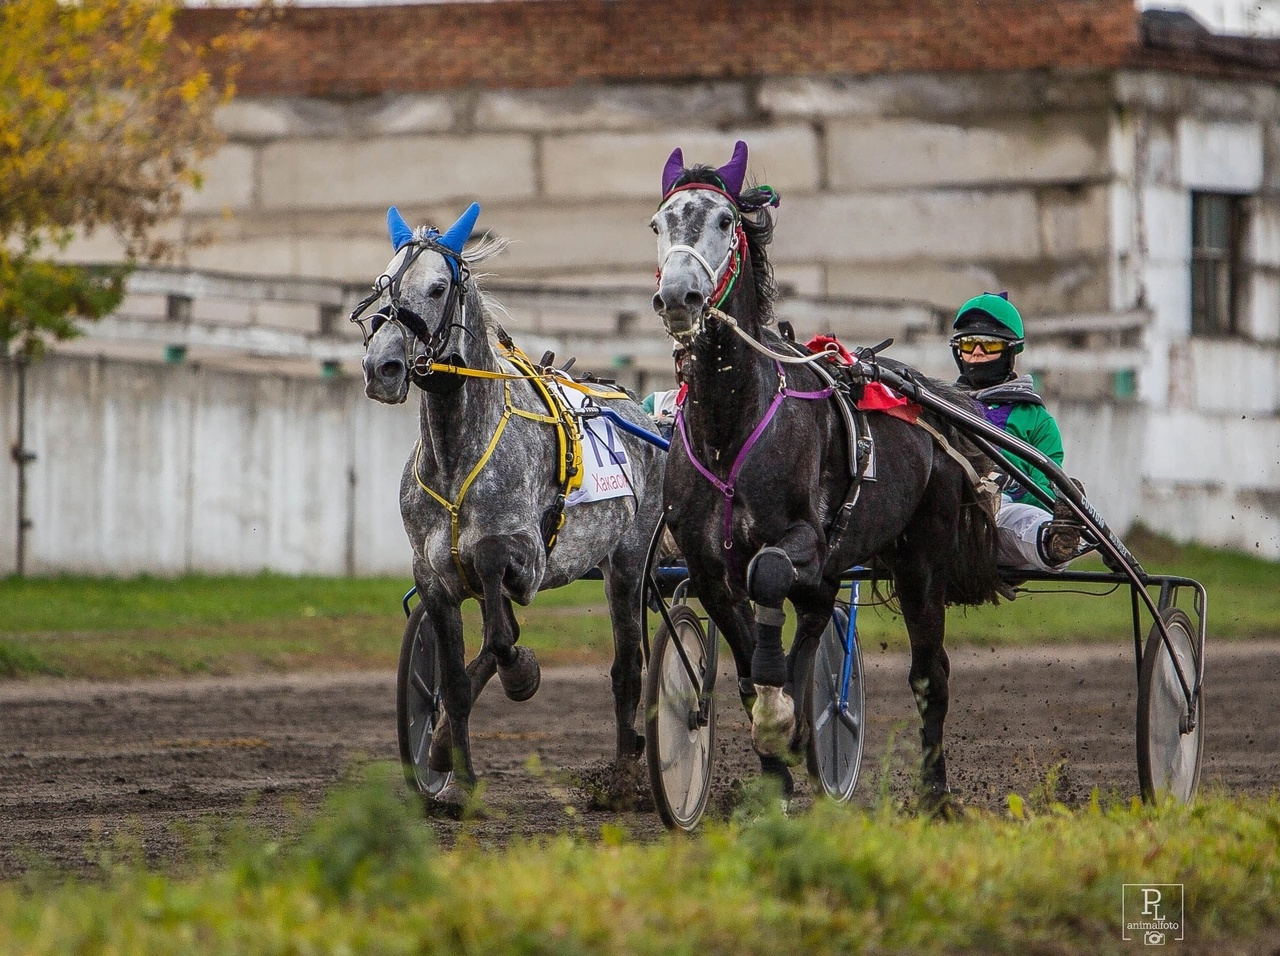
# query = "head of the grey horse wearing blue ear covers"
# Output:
<box><xmin>352</xmin><ymin>202</ymin><xmax>480</xmax><ymax>404</ymax></box>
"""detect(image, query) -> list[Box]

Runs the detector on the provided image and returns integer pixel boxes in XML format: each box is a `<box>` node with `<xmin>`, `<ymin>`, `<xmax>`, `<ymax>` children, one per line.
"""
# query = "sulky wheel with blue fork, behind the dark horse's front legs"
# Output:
<box><xmin>805</xmin><ymin>608</ymin><xmax>865</xmax><ymax>802</ymax></box>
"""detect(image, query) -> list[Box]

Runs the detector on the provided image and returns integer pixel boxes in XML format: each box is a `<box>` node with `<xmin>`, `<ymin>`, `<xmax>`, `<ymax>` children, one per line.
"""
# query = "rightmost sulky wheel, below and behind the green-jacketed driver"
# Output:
<box><xmin>1138</xmin><ymin>608</ymin><xmax>1204</xmax><ymax>804</ymax></box>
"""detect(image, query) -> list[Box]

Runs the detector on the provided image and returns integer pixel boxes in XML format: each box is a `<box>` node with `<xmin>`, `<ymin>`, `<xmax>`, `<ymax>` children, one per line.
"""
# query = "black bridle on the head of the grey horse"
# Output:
<box><xmin>347</xmin><ymin>229</ymin><xmax>471</xmax><ymax>388</ymax></box>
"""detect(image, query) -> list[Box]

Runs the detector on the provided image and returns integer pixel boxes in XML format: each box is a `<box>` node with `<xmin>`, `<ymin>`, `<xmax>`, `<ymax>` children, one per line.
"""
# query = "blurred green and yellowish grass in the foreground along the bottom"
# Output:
<box><xmin>0</xmin><ymin>767</ymin><xmax>1280</xmax><ymax>956</ymax></box>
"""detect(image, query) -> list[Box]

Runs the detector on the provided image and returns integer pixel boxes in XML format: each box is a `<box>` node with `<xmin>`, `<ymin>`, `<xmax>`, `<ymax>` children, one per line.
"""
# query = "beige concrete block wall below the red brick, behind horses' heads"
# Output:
<box><xmin>67</xmin><ymin>72</ymin><xmax>1136</xmax><ymax>330</ymax></box>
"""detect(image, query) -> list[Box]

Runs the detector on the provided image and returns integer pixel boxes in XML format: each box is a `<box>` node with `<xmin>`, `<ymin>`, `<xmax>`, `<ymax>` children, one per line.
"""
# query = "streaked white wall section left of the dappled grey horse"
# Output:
<box><xmin>0</xmin><ymin>356</ymin><xmax>417</xmax><ymax>576</ymax></box>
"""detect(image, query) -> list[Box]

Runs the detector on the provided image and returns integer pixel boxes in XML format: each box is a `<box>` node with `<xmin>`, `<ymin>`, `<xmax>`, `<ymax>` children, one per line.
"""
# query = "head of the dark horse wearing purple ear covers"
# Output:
<box><xmin>649</xmin><ymin>139</ymin><xmax>777</xmax><ymax>342</ymax></box>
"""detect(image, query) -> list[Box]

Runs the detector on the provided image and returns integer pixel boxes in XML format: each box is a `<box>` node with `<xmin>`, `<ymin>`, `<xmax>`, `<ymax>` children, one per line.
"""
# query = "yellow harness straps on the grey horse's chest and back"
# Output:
<box><xmin>413</xmin><ymin>348</ymin><xmax>596</xmax><ymax>600</ymax></box>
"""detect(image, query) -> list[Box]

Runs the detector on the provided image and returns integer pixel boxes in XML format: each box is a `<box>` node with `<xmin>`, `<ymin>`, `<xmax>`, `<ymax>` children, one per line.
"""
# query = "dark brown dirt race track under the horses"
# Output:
<box><xmin>0</xmin><ymin>641</ymin><xmax>1280</xmax><ymax>877</ymax></box>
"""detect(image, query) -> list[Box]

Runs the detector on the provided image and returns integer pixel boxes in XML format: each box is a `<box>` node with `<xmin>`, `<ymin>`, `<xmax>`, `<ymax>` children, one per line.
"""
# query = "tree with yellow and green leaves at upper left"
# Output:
<box><xmin>0</xmin><ymin>0</ymin><xmax>238</xmax><ymax>356</ymax></box>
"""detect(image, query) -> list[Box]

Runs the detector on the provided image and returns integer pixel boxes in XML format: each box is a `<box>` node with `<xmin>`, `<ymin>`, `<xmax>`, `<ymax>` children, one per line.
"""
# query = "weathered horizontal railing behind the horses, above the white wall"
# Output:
<box><xmin>64</xmin><ymin>267</ymin><xmax>1149</xmax><ymax>379</ymax></box>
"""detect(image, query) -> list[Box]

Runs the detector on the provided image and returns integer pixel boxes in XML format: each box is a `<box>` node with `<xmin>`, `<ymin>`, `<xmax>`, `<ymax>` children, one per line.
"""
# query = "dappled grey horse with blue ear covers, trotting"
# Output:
<box><xmin>364</xmin><ymin>203</ymin><xmax>664</xmax><ymax>795</ymax></box>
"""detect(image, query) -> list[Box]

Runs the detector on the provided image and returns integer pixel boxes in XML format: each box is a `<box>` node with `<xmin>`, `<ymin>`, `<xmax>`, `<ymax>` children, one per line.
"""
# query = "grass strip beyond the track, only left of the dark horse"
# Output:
<box><xmin>0</xmin><ymin>575</ymin><xmax>624</xmax><ymax>680</ymax></box>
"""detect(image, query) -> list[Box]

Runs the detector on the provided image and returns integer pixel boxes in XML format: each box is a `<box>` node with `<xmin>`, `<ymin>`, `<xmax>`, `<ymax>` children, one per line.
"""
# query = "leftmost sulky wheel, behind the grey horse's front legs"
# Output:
<box><xmin>396</xmin><ymin>603</ymin><xmax>453</xmax><ymax>797</ymax></box>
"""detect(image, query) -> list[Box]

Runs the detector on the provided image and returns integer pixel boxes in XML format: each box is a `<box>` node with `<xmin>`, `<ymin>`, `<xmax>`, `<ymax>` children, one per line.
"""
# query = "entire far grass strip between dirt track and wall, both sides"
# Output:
<box><xmin>0</xmin><ymin>531</ymin><xmax>1280</xmax><ymax>680</ymax></box>
